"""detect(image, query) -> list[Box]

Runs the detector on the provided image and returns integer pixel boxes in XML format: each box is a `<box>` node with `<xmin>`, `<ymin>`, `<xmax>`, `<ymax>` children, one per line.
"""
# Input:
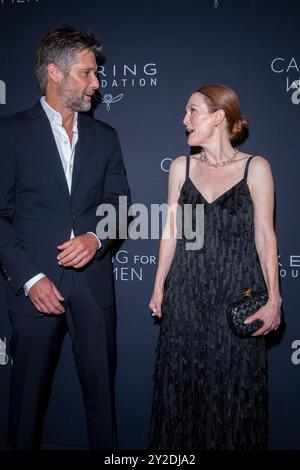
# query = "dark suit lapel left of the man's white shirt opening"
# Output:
<box><xmin>28</xmin><ymin>103</ymin><xmax>70</xmax><ymax>196</ymax></box>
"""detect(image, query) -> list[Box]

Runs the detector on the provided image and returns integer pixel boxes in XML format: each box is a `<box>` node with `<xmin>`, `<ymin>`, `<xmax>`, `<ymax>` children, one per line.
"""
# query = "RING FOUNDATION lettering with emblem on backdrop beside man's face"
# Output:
<box><xmin>98</xmin><ymin>62</ymin><xmax>158</xmax><ymax>111</ymax></box>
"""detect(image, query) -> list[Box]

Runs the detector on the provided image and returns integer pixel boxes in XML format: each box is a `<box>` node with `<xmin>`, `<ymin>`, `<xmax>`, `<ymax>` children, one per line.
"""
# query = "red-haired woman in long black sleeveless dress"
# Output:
<box><xmin>149</xmin><ymin>84</ymin><xmax>281</xmax><ymax>450</ymax></box>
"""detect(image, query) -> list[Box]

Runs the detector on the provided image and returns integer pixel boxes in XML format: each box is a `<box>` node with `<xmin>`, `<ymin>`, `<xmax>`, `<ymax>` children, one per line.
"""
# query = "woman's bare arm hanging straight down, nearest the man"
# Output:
<box><xmin>149</xmin><ymin>157</ymin><xmax>186</xmax><ymax>317</ymax></box>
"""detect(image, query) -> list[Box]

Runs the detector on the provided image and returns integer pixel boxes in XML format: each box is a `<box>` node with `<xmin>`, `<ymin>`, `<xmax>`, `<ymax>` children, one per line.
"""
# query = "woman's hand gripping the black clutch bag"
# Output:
<box><xmin>245</xmin><ymin>300</ymin><xmax>281</xmax><ymax>336</ymax></box>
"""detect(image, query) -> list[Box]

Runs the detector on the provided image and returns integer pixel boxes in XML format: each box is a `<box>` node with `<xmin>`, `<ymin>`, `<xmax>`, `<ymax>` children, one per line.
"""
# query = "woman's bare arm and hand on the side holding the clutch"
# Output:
<box><xmin>245</xmin><ymin>157</ymin><xmax>281</xmax><ymax>336</ymax></box>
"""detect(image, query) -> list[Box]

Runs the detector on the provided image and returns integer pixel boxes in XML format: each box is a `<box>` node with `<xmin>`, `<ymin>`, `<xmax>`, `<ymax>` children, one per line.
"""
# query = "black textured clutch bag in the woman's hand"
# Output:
<box><xmin>226</xmin><ymin>288</ymin><xmax>269</xmax><ymax>338</ymax></box>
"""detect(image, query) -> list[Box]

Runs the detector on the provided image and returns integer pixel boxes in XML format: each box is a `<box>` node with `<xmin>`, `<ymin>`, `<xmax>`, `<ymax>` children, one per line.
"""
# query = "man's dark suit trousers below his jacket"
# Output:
<box><xmin>8</xmin><ymin>270</ymin><xmax>116</xmax><ymax>450</ymax></box>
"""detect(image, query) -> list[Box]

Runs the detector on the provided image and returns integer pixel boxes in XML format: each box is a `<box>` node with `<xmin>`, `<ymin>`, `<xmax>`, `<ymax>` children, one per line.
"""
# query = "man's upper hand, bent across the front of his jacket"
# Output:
<box><xmin>57</xmin><ymin>233</ymin><xmax>99</xmax><ymax>269</ymax></box>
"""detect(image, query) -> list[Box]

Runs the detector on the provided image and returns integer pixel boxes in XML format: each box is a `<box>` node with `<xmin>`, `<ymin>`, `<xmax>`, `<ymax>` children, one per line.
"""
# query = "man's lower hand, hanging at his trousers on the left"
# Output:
<box><xmin>28</xmin><ymin>277</ymin><xmax>65</xmax><ymax>315</ymax></box>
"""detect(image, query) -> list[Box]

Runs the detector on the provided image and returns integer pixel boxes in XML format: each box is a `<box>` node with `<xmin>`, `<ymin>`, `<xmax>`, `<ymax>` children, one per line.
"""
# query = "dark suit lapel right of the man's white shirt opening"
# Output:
<box><xmin>71</xmin><ymin>114</ymin><xmax>94</xmax><ymax>197</ymax></box>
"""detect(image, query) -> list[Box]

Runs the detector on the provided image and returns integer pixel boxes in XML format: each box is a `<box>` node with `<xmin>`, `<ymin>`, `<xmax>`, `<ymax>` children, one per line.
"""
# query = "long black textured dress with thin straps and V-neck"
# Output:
<box><xmin>149</xmin><ymin>157</ymin><xmax>267</xmax><ymax>450</ymax></box>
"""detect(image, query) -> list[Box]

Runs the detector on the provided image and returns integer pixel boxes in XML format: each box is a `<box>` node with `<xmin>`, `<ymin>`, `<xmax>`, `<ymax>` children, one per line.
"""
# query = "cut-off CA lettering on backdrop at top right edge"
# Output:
<box><xmin>271</xmin><ymin>57</ymin><xmax>300</xmax><ymax>105</ymax></box>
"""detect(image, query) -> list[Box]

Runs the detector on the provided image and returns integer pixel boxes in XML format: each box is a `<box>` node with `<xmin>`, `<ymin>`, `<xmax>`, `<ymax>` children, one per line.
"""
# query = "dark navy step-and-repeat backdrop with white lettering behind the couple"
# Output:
<box><xmin>0</xmin><ymin>0</ymin><xmax>300</xmax><ymax>449</ymax></box>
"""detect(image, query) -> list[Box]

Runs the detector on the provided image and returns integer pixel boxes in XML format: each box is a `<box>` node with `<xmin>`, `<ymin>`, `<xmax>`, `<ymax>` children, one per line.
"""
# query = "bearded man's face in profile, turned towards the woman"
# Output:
<box><xmin>59</xmin><ymin>50</ymin><xmax>99</xmax><ymax>112</ymax></box>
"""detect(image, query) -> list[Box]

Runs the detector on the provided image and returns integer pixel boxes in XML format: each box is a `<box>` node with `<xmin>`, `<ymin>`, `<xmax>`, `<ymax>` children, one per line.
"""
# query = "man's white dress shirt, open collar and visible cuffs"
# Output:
<box><xmin>24</xmin><ymin>96</ymin><xmax>101</xmax><ymax>295</ymax></box>
